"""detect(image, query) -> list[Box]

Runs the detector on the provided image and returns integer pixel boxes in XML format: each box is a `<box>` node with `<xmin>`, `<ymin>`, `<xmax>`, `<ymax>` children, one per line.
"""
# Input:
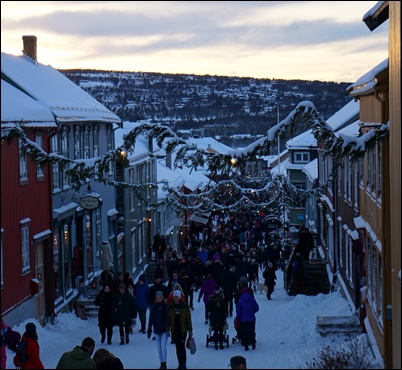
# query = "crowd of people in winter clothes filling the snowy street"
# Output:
<box><xmin>2</xmin><ymin>212</ymin><xmax>314</xmax><ymax>369</ymax></box>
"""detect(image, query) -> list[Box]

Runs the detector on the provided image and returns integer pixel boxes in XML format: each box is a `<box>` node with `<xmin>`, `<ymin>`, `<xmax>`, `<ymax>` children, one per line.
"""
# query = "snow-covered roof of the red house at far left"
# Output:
<box><xmin>1</xmin><ymin>80</ymin><xmax>56</xmax><ymax>127</ymax></box>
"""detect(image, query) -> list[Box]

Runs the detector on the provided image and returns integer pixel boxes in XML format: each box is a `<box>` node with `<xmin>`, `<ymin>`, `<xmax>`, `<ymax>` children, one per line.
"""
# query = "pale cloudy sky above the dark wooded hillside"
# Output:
<box><xmin>1</xmin><ymin>1</ymin><xmax>388</xmax><ymax>82</ymax></box>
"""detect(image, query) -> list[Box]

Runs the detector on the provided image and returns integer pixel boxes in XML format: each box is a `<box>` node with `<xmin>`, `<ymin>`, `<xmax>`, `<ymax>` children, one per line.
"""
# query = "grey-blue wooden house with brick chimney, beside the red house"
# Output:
<box><xmin>1</xmin><ymin>36</ymin><xmax>121</xmax><ymax>324</ymax></box>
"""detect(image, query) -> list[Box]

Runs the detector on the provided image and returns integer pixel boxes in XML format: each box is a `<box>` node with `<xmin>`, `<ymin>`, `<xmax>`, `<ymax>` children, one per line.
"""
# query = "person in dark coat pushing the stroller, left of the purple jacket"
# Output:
<box><xmin>209</xmin><ymin>287</ymin><xmax>226</xmax><ymax>349</ymax></box>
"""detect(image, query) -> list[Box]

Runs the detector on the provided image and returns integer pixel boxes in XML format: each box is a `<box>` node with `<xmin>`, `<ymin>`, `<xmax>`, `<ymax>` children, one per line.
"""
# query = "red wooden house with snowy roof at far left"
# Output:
<box><xmin>1</xmin><ymin>80</ymin><xmax>57</xmax><ymax>325</ymax></box>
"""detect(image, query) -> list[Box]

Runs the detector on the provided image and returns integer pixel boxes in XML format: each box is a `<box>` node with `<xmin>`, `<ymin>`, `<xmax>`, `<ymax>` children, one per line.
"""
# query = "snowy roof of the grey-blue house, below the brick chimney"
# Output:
<box><xmin>1</xmin><ymin>52</ymin><xmax>121</xmax><ymax>124</ymax></box>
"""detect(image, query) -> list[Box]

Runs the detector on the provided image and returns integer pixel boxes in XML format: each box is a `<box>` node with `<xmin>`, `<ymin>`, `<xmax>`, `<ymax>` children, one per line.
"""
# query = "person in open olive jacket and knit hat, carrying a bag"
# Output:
<box><xmin>166</xmin><ymin>290</ymin><xmax>193</xmax><ymax>369</ymax></box>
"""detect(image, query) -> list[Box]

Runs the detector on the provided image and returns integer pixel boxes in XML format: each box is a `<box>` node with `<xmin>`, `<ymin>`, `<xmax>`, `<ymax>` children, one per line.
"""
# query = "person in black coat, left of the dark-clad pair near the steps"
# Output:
<box><xmin>94</xmin><ymin>285</ymin><xmax>114</xmax><ymax>344</ymax></box>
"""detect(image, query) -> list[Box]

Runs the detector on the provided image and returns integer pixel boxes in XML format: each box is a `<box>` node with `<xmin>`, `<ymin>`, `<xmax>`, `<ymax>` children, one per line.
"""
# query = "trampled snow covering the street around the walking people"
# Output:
<box><xmin>6</xmin><ymin>271</ymin><xmax>372</xmax><ymax>369</ymax></box>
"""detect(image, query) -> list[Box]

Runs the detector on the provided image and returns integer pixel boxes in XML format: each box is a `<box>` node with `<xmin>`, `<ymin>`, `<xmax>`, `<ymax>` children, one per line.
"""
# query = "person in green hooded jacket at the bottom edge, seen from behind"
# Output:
<box><xmin>56</xmin><ymin>337</ymin><xmax>96</xmax><ymax>369</ymax></box>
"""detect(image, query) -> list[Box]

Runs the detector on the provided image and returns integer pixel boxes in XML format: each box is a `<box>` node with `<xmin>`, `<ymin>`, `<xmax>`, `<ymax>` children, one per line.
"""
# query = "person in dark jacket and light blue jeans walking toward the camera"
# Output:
<box><xmin>147</xmin><ymin>291</ymin><xmax>167</xmax><ymax>369</ymax></box>
